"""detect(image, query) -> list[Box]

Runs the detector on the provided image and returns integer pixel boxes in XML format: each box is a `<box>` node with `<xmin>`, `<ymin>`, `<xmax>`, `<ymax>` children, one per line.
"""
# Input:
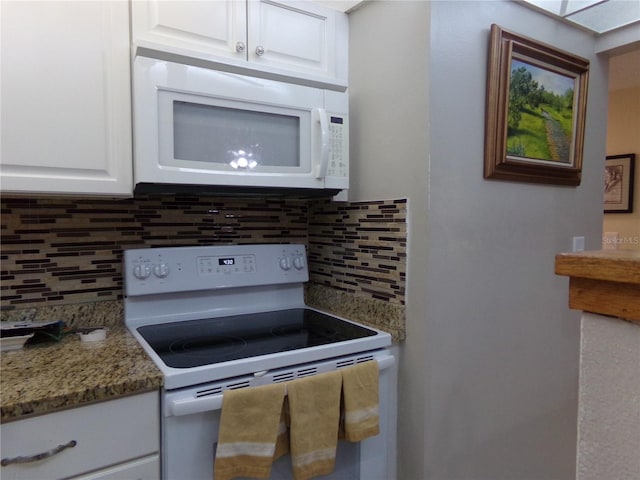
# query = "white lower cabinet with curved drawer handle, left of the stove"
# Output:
<box><xmin>0</xmin><ymin>391</ymin><xmax>160</xmax><ymax>480</ymax></box>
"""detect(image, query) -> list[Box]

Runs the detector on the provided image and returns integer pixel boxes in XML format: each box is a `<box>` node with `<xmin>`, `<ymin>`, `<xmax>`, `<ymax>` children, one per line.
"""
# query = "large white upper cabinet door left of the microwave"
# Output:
<box><xmin>0</xmin><ymin>0</ymin><xmax>132</xmax><ymax>195</ymax></box>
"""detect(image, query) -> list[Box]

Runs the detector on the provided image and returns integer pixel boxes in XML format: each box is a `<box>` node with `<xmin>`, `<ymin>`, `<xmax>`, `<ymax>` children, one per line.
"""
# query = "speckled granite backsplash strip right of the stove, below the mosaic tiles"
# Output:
<box><xmin>305</xmin><ymin>283</ymin><xmax>406</xmax><ymax>342</ymax></box>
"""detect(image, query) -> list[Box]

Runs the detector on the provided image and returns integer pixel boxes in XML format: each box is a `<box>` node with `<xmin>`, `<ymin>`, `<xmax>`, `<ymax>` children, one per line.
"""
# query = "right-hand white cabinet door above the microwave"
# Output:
<box><xmin>248</xmin><ymin>0</ymin><xmax>348</xmax><ymax>82</ymax></box>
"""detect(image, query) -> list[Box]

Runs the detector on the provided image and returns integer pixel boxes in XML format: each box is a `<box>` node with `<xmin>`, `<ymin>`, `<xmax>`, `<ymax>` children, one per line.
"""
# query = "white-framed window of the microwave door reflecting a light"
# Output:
<box><xmin>158</xmin><ymin>91</ymin><xmax>311</xmax><ymax>174</ymax></box>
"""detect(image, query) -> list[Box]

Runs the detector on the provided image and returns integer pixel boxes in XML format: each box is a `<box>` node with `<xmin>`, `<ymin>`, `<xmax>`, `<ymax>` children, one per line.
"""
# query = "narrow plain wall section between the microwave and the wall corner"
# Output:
<box><xmin>349</xmin><ymin>1</ymin><xmax>429</xmax><ymax>480</ymax></box>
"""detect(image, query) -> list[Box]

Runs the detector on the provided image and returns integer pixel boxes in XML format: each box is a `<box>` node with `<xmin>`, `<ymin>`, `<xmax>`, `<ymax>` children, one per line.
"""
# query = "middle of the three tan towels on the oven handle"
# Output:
<box><xmin>286</xmin><ymin>370</ymin><xmax>342</xmax><ymax>480</ymax></box>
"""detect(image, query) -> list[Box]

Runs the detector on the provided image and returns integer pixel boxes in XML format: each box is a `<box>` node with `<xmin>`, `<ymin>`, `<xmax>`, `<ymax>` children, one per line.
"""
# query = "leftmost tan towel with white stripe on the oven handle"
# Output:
<box><xmin>214</xmin><ymin>383</ymin><xmax>286</xmax><ymax>480</ymax></box>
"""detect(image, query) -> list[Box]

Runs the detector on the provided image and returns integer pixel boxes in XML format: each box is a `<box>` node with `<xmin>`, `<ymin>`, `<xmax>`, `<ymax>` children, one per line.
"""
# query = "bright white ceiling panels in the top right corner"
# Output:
<box><xmin>521</xmin><ymin>0</ymin><xmax>640</xmax><ymax>35</ymax></box>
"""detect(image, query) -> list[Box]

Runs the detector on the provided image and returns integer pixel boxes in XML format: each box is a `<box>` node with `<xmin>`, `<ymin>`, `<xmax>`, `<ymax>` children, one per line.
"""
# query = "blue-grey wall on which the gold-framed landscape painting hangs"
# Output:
<box><xmin>426</xmin><ymin>1</ymin><xmax>607</xmax><ymax>480</ymax></box>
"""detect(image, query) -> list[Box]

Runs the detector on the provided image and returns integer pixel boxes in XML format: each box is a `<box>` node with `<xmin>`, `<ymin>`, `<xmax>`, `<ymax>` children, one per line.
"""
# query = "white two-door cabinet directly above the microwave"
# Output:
<box><xmin>132</xmin><ymin>0</ymin><xmax>348</xmax><ymax>89</ymax></box>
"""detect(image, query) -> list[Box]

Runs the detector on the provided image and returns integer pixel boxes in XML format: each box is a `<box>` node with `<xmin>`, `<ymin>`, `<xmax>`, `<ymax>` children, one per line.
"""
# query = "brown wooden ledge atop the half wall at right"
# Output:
<box><xmin>555</xmin><ymin>250</ymin><xmax>640</xmax><ymax>324</ymax></box>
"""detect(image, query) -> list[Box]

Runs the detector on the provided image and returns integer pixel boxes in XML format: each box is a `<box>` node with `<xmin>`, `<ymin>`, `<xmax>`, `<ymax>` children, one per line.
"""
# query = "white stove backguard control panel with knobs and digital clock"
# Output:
<box><xmin>124</xmin><ymin>244</ymin><xmax>309</xmax><ymax>296</ymax></box>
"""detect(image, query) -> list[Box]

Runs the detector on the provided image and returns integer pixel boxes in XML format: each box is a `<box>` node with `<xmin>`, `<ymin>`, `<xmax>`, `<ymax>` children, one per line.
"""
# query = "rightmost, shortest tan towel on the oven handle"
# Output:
<box><xmin>341</xmin><ymin>361</ymin><xmax>380</xmax><ymax>442</ymax></box>
